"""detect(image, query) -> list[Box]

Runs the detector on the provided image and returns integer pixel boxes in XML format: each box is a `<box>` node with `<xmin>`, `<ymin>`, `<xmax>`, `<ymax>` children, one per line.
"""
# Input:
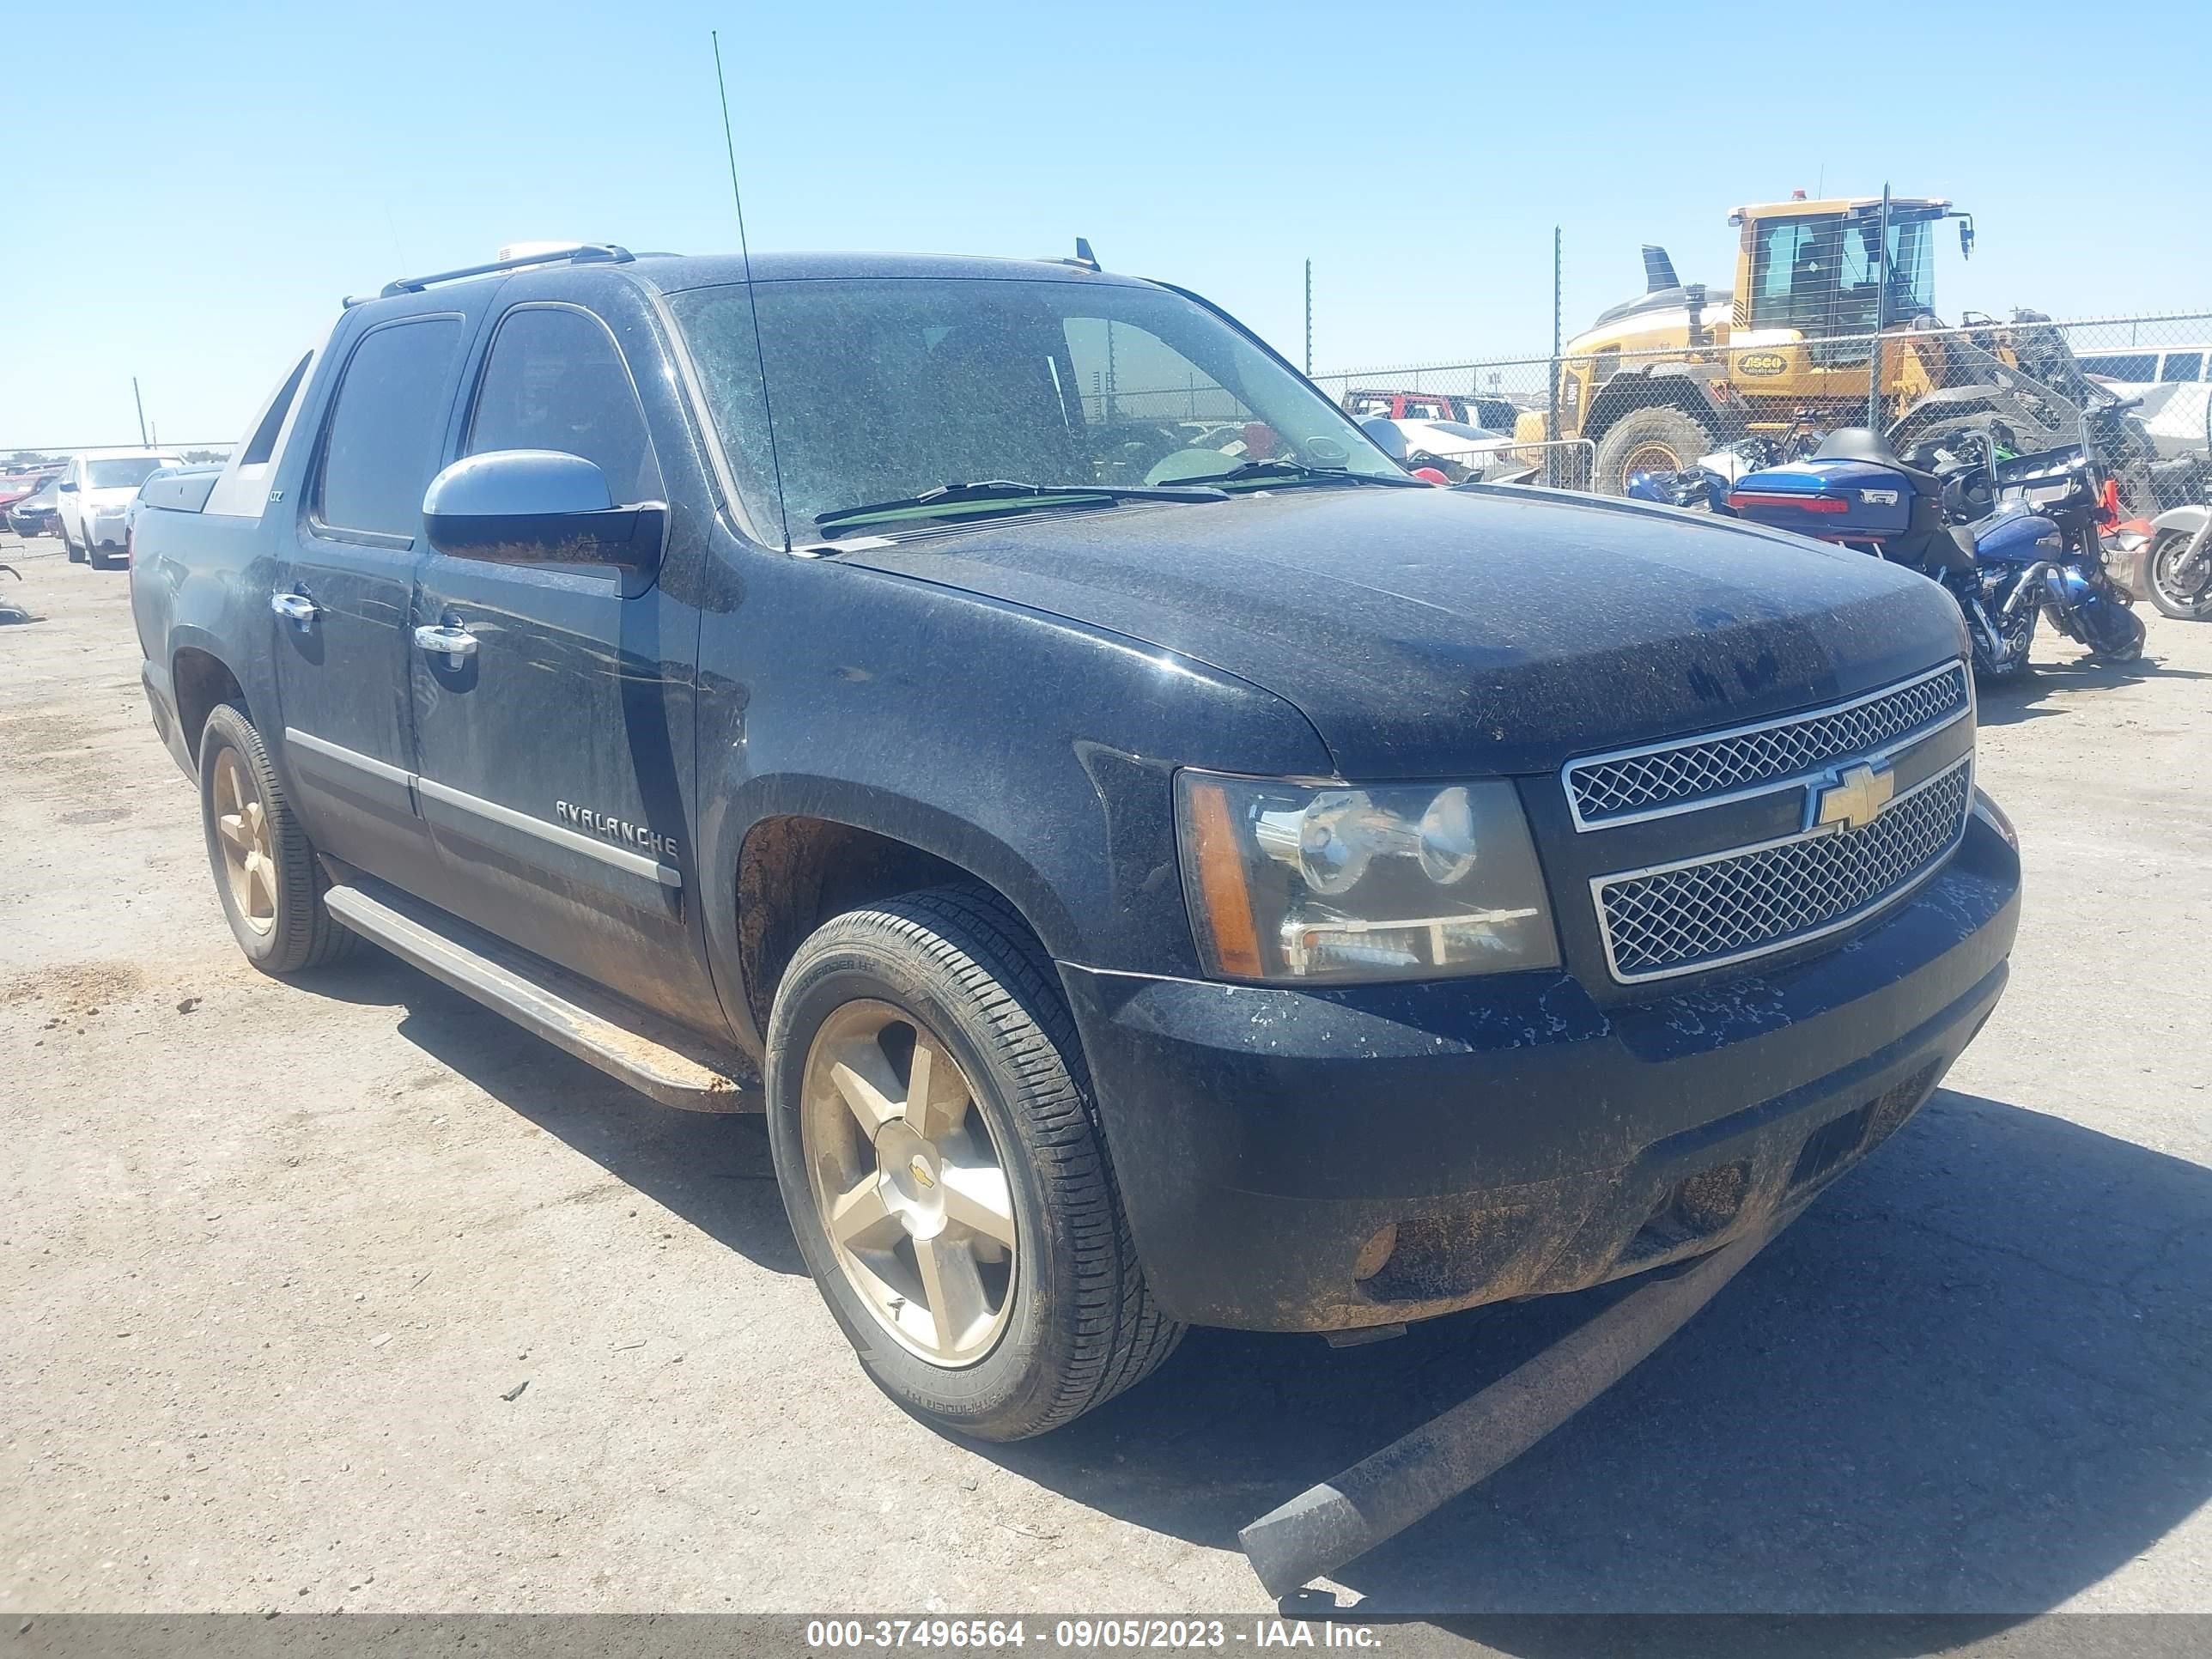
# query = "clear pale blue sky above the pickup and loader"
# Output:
<box><xmin>0</xmin><ymin>0</ymin><xmax>2212</xmax><ymax>452</ymax></box>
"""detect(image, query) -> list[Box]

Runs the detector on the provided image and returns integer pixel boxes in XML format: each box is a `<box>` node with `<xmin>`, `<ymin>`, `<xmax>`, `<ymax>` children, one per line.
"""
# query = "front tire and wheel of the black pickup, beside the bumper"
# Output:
<box><xmin>768</xmin><ymin>887</ymin><xmax>1182</xmax><ymax>1440</ymax></box>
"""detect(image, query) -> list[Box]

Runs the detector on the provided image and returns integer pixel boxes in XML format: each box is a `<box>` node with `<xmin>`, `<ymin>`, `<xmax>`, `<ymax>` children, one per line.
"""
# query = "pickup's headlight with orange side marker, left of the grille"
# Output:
<box><xmin>1175</xmin><ymin>769</ymin><xmax>1559</xmax><ymax>982</ymax></box>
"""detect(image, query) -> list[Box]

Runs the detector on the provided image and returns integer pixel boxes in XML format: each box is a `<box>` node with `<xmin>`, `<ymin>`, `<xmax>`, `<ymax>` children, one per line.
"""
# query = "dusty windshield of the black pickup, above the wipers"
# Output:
<box><xmin>668</xmin><ymin>276</ymin><xmax>1405</xmax><ymax>540</ymax></box>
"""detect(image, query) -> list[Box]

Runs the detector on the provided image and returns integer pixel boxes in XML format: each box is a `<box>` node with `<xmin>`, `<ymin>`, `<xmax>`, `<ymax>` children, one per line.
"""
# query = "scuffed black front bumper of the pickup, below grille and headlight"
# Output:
<box><xmin>1061</xmin><ymin>817</ymin><xmax>2020</xmax><ymax>1329</ymax></box>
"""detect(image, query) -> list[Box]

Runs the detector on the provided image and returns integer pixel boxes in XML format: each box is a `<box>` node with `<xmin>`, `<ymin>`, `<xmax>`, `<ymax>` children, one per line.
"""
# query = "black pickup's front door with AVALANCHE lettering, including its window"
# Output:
<box><xmin>411</xmin><ymin>283</ymin><xmax>721</xmax><ymax>1030</ymax></box>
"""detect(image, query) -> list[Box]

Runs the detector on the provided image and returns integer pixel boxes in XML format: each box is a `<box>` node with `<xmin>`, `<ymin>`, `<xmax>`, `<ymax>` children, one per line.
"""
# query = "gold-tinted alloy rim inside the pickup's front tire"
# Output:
<box><xmin>799</xmin><ymin>1000</ymin><xmax>1018</xmax><ymax>1370</ymax></box>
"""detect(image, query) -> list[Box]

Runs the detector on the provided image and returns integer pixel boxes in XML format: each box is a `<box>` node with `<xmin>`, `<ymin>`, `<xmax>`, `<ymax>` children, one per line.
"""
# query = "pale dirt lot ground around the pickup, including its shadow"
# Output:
<box><xmin>0</xmin><ymin>538</ymin><xmax>2212</xmax><ymax>1617</ymax></box>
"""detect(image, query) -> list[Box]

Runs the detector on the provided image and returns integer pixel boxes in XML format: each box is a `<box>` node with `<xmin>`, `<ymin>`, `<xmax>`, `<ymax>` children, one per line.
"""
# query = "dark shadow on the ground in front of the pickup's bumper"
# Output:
<box><xmin>988</xmin><ymin>1093</ymin><xmax>2212</xmax><ymax>1650</ymax></box>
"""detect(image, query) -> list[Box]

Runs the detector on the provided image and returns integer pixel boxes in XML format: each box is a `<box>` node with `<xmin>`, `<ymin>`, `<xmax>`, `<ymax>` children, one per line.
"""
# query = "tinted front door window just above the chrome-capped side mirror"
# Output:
<box><xmin>465</xmin><ymin>305</ymin><xmax>665</xmax><ymax>507</ymax></box>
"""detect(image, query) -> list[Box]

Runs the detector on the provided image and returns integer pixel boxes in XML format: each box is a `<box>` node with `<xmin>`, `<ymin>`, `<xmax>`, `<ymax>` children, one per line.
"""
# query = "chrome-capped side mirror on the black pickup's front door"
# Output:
<box><xmin>422</xmin><ymin>449</ymin><xmax>668</xmax><ymax>571</ymax></box>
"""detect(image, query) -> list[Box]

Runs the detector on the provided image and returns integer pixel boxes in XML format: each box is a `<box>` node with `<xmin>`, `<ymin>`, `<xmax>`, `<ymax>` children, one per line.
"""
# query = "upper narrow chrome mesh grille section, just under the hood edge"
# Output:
<box><xmin>1562</xmin><ymin>661</ymin><xmax>1973</xmax><ymax>830</ymax></box>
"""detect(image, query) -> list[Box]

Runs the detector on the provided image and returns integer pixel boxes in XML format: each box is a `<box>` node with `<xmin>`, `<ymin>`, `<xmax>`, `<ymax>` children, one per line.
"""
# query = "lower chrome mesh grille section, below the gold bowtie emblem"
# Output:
<box><xmin>1590</xmin><ymin>754</ymin><xmax>1973</xmax><ymax>984</ymax></box>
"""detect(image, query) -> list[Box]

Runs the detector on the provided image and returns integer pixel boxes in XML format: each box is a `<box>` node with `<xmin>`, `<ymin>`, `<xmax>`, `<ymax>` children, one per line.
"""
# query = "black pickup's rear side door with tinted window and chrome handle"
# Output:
<box><xmin>270</xmin><ymin>296</ymin><xmax>483</xmax><ymax>887</ymax></box>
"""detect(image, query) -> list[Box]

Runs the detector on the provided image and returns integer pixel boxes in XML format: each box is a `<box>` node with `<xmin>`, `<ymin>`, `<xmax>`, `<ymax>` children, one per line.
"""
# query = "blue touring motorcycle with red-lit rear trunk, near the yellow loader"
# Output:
<box><xmin>1728</xmin><ymin>417</ymin><xmax>2143</xmax><ymax>681</ymax></box>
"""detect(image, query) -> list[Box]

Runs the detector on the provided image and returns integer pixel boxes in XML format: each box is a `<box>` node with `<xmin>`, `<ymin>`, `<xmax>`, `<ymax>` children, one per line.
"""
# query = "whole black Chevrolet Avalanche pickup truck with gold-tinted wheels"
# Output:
<box><xmin>133</xmin><ymin>246</ymin><xmax>2020</xmax><ymax>1440</ymax></box>
